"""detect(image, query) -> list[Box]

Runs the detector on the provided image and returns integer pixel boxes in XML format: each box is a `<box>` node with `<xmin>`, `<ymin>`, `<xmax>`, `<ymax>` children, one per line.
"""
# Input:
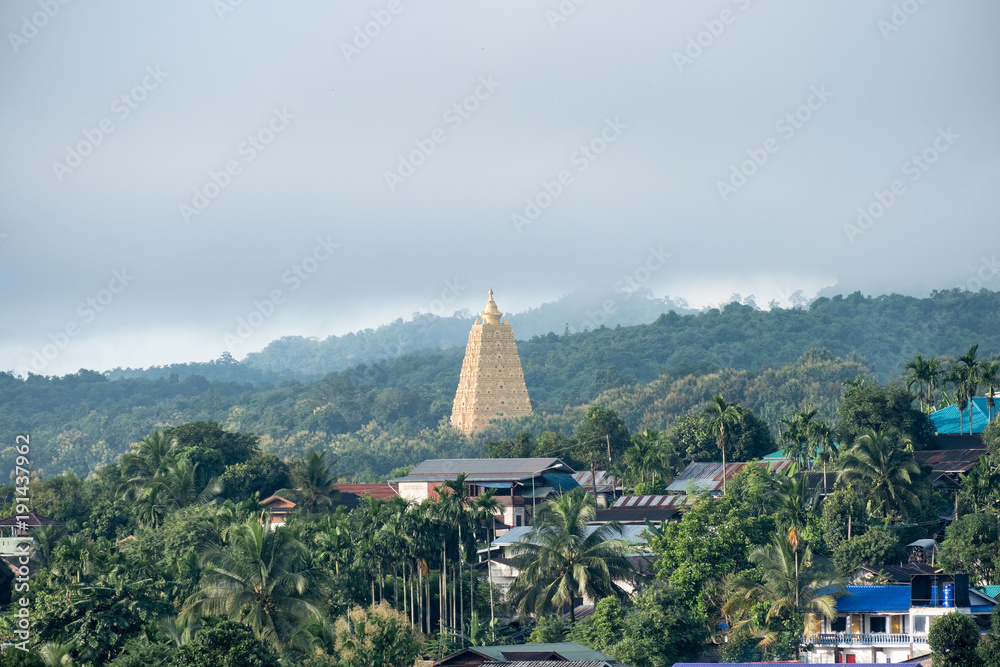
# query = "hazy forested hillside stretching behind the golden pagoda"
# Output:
<box><xmin>0</xmin><ymin>291</ymin><xmax>1000</xmax><ymax>480</ymax></box>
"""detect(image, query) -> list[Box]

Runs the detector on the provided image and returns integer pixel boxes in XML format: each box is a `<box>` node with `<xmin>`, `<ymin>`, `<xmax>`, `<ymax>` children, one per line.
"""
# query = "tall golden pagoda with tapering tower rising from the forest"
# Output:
<box><xmin>451</xmin><ymin>287</ymin><xmax>531</xmax><ymax>435</ymax></box>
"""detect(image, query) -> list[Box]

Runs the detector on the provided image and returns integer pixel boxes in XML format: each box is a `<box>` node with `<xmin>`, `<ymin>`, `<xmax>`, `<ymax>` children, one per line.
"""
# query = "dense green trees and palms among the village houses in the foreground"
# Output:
<box><xmin>0</xmin><ymin>366</ymin><xmax>1000</xmax><ymax>667</ymax></box>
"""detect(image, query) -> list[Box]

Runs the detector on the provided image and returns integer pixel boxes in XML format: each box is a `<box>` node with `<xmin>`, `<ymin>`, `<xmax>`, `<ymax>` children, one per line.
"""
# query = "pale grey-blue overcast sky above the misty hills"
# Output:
<box><xmin>0</xmin><ymin>0</ymin><xmax>1000</xmax><ymax>374</ymax></box>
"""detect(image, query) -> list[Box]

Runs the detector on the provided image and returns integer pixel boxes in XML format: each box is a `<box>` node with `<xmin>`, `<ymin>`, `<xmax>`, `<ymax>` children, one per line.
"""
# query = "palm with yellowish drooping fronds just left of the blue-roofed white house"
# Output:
<box><xmin>723</xmin><ymin>530</ymin><xmax>844</xmax><ymax>659</ymax></box>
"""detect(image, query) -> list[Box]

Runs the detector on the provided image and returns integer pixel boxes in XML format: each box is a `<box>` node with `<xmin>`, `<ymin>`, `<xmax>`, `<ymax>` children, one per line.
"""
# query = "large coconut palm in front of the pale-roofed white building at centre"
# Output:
<box><xmin>510</xmin><ymin>489</ymin><xmax>635</xmax><ymax>622</ymax></box>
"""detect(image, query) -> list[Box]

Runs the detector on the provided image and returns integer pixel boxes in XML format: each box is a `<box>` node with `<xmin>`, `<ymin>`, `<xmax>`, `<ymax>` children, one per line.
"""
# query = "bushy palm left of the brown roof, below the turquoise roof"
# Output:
<box><xmin>837</xmin><ymin>430</ymin><xmax>930</xmax><ymax>518</ymax></box>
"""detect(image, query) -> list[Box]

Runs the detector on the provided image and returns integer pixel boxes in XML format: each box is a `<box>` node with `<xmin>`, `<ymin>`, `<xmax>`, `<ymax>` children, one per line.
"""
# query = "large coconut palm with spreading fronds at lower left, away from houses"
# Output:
<box><xmin>178</xmin><ymin>520</ymin><xmax>325</xmax><ymax>649</ymax></box>
